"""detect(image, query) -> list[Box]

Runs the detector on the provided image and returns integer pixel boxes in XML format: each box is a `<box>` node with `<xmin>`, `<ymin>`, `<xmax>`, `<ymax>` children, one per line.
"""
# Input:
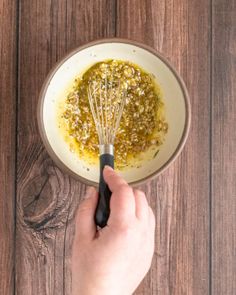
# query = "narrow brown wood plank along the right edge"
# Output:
<box><xmin>212</xmin><ymin>0</ymin><xmax>236</xmax><ymax>295</ymax></box>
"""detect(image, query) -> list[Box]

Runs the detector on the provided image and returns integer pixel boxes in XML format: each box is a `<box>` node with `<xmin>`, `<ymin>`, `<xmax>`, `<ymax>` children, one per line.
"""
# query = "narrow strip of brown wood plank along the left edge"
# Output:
<box><xmin>0</xmin><ymin>0</ymin><xmax>17</xmax><ymax>295</ymax></box>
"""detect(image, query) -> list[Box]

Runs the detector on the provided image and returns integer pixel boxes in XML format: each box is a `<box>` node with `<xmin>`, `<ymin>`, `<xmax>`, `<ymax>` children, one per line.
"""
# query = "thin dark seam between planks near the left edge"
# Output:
<box><xmin>13</xmin><ymin>0</ymin><xmax>20</xmax><ymax>295</ymax></box>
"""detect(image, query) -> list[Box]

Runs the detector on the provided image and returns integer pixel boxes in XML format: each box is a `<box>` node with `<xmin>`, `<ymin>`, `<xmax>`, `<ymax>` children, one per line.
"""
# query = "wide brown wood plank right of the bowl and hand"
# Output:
<box><xmin>116</xmin><ymin>0</ymin><xmax>210</xmax><ymax>295</ymax></box>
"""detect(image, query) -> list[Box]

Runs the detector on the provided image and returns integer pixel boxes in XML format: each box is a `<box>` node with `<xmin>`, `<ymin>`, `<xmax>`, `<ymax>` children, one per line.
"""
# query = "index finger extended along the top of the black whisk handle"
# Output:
<box><xmin>104</xmin><ymin>168</ymin><xmax>135</xmax><ymax>225</ymax></box>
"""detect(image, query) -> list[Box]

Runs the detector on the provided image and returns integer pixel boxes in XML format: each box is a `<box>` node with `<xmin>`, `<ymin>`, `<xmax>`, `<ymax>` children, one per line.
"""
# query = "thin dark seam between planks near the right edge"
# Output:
<box><xmin>209</xmin><ymin>0</ymin><xmax>213</xmax><ymax>295</ymax></box>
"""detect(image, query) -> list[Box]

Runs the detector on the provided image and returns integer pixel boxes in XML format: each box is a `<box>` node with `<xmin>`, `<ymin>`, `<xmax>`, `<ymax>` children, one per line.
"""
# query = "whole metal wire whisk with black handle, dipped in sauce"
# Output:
<box><xmin>88</xmin><ymin>76</ymin><xmax>126</xmax><ymax>227</ymax></box>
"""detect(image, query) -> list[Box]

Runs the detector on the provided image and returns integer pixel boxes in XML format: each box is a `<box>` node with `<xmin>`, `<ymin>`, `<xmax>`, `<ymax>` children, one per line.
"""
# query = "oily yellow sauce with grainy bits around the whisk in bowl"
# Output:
<box><xmin>59</xmin><ymin>60</ymin><xmax>168</xmax><ymax>169</ymax></box>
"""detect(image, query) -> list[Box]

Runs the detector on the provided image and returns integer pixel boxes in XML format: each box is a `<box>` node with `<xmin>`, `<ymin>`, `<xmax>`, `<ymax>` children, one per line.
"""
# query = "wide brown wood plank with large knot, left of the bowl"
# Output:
<box><xmin>16</xmin><ymin>0</ymin><xmax>115</xmax><ymax>295</ymax></box>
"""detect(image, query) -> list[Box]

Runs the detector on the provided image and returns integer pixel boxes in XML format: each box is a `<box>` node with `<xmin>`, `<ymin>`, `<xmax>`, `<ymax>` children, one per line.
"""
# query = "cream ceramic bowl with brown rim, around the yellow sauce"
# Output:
<box><xmin>38</xmin><ymin>38</ymin><xmax>190</xmax><ymax>185</ymax></box>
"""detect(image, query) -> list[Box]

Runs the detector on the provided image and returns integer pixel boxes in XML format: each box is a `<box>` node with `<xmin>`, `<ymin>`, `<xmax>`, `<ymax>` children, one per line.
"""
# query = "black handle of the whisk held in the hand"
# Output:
<box><xmin>95</xmin><ymin>154</ymin><xmax>114</xmax><ymax>227</ymax></box>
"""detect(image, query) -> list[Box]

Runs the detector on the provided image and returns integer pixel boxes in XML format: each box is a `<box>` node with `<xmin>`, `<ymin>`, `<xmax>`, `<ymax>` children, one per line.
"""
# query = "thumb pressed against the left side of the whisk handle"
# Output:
<box><xmin>75</xmin><ymin>187</ymin><xmax>98</xmax><ymax>241</ymax></box>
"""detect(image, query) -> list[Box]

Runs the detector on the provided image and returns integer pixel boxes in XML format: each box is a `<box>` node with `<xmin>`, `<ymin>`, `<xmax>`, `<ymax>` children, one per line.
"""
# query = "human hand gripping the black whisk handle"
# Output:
<box><xmin>72</xmin><ymin>167</ymin><xmax>155</xmax><ymax>295</ymax></box>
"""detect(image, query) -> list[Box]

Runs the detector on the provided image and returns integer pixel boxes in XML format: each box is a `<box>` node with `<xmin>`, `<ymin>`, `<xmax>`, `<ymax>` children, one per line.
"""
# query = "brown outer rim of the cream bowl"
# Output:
<box><xmin>37</xmin><ymin>37</ymin><xmax>191</xmax><ymax>186</ymax></box>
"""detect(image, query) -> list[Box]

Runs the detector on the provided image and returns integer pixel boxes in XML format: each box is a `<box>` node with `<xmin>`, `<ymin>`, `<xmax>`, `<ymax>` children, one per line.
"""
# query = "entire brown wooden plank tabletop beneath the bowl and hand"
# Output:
<box><xmin>0</xmin><ymin>0</ymin><xmax>236</xmax><ymax>295</ymax></box>
